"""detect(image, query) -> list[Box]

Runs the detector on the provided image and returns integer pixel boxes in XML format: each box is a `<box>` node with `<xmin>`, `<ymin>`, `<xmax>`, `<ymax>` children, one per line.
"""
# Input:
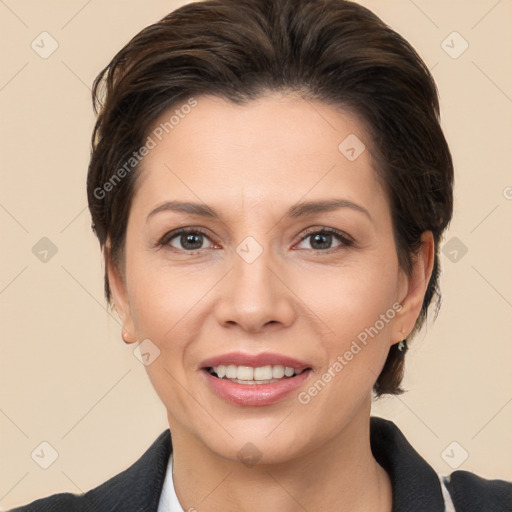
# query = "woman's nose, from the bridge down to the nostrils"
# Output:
<box><xmin>216</xmin><ymin>242</ymin><xmax>297</xmax><ymax>333</ymax></box>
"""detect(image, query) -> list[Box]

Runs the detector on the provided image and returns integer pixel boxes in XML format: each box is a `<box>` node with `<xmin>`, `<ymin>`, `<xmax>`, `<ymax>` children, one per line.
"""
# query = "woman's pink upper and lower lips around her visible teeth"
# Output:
<box><xmin>200</xmin><ymin>352</ymin><xmax>311</xmax><ymax>407</ymax></box>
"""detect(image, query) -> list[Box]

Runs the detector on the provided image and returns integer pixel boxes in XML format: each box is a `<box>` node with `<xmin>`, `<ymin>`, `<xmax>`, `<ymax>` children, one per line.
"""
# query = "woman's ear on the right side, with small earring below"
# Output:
<box><xmin>391</xmin><ymin>231</ymin><xmax>435</xmax><ymax>344</ymax></box>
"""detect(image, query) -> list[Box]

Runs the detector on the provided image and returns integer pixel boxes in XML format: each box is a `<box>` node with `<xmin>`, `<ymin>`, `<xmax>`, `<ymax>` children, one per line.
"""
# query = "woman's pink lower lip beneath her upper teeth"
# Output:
<box><xmin>202</xmin><ymin>369</ymin><xmax>310</xmax><ymax>407</ymax></box>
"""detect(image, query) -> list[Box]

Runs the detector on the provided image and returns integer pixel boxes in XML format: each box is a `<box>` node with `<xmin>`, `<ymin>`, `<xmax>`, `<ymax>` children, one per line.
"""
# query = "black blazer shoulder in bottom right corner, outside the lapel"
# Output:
<box><xmin>444</xmin><ymin>471</ymin><xmax>512</xmax><ymax>512</ymax></box>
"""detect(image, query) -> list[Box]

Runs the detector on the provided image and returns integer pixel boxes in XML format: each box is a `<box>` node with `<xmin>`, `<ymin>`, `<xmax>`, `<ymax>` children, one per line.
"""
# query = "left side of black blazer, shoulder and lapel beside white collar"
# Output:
<box><xmin>10</xmin><ymin>429</ymin><xmax>172</xmax><ymax>512</ymax></box>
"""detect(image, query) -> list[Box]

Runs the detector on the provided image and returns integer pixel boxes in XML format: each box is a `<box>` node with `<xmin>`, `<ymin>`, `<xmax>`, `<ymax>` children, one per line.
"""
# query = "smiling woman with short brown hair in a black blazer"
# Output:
<box><xmin>10</xmin><ymin>0</ymin><xmax>512</xmax><ymax>512</ymax></box>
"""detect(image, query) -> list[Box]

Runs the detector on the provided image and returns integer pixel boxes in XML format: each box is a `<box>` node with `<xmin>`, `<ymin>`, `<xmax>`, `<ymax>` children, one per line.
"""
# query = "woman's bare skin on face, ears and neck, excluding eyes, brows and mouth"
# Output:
<box><xmin>107</xmin><ymin>93</ymin><xmax>434</xmax><ymax>512</ymax></box>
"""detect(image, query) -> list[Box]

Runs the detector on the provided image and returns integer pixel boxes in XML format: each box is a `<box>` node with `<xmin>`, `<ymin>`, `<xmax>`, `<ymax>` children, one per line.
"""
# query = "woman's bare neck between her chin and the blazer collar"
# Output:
<box><xmin>170</xmin><ymin>407</ymin><xmax>392</xmax><ymax>512</ymax></box>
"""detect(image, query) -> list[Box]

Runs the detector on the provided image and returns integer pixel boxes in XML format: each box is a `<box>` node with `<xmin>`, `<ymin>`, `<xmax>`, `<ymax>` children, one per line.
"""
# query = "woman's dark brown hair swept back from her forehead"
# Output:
<box><xmin>87</xmin><ymin>0</ymin><xmax>453</xmax><ymax>395</ymax></box>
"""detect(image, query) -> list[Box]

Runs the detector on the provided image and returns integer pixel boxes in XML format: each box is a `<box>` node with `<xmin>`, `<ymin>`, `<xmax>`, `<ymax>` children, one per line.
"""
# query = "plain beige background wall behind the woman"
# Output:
<box><xmin>0</xmin><ymin>0</ymin><xmax>512</xmax><ymax>509</ymax></box>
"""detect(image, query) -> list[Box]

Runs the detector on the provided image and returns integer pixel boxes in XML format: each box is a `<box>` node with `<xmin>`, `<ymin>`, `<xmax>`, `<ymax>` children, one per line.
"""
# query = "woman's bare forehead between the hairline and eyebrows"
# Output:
<box><xmin>130</xmin><ymin>93</ymin><xmax>384</xmax><ymax>217</ymax></box>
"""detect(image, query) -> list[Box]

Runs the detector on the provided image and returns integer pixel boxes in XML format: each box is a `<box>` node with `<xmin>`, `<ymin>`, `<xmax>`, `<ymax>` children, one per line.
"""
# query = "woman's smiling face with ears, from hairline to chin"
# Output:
<box><xmin>109</xmin><ymin>94</ymin><xmax>432</xmax><ymax>462</ymax></box>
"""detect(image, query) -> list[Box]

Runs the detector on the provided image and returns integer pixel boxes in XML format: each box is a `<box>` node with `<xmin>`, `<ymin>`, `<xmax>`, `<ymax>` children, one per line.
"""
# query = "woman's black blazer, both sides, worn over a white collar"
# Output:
<box><xmin>11</xmin><ymin>417</ymin><xmax>512</xmax><ymax>512</ymax></box>
